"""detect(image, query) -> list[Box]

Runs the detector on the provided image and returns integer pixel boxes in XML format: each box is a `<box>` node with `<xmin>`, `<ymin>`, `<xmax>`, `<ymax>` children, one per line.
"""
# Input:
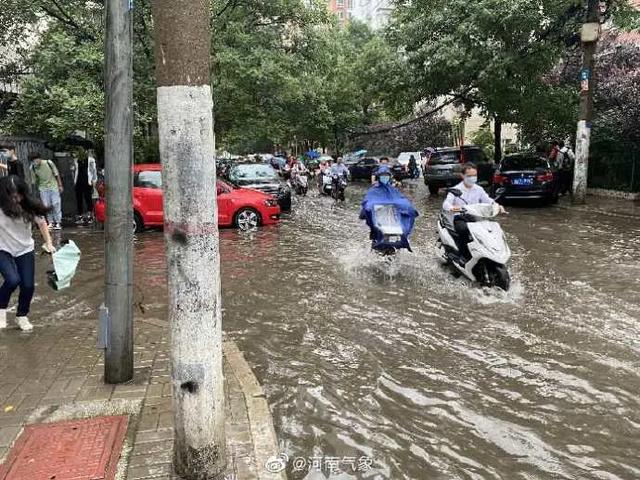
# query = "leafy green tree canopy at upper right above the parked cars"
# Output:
<box><xmin>389</xmin><ymin>0</ymin><xmax>592</xmax><ymax>160</ymax></box>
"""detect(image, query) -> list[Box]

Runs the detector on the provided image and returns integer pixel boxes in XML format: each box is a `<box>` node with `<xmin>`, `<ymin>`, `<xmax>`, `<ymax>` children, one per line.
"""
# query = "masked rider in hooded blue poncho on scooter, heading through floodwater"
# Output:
<box><xmin>360</xmin><ymin>165</ymin><xmax>418</xmax><ymax>252</ymax></box>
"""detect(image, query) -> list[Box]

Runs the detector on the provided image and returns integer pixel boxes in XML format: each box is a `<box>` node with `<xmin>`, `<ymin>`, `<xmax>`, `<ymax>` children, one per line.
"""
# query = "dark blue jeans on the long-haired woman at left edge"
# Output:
<box><xmin>0</xmin><ymin>251</ymin><xmax>36</xmax><ymax>317</ymax></box>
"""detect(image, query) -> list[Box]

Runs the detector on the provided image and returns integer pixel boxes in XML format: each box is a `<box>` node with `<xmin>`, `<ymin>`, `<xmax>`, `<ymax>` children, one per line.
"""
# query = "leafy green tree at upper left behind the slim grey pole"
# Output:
<box><xmin>0</xmin><ymin>0</ymin><xmax>157</xmax><ymax>160</ymax></box>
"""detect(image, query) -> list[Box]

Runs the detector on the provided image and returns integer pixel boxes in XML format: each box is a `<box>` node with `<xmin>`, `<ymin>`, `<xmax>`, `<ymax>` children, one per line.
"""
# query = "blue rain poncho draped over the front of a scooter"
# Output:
<box><xmin>360</xmin><ymin>183</ymin><xmax>418</xmax><ymax>251</ymax></box>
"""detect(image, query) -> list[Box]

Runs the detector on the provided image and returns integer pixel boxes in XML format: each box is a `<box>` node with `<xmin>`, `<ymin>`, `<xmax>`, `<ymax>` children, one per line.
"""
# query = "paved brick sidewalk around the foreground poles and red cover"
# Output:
<box><xmin>0</xmin><ymin>318</ymin><xmax>284</xmax><ymax>480</ymax></box>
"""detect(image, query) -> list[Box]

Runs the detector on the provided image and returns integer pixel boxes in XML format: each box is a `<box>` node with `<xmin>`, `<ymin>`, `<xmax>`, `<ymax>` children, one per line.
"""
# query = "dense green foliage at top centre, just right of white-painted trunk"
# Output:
<box><xmin>213</xmin><ymin>8</ymin><xmax>405</xmax><ymax>151</ymax></box>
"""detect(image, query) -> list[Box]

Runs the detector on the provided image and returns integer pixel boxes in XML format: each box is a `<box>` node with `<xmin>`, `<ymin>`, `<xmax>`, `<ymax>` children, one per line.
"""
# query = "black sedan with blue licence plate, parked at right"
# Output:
<box><xmin>492</xmin><ymin>153</ymin><xmax>559</xmax><ymax>203</ymax></box>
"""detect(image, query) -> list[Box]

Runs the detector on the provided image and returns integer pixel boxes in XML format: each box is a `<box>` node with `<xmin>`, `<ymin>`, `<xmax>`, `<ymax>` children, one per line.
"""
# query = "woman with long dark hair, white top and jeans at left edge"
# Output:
<box><xmin>0</xmin><ymin>175</ymin><xmax>55</xmax><ymax>331</ymax></box>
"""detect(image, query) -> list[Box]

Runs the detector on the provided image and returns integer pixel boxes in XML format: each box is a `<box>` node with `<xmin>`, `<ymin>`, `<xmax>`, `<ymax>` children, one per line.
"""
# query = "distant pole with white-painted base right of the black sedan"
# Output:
<box><xmin>573</xmin><ymin>0</ymin><xmax>600</xmax><ymax>203</ymax></box>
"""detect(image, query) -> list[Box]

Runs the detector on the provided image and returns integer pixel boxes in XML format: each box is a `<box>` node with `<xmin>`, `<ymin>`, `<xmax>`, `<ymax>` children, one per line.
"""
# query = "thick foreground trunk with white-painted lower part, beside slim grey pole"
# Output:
<box><xmin>153</xmin><ymin>0</ymin><xmax>225</xmax><ymax>480</ymax></box>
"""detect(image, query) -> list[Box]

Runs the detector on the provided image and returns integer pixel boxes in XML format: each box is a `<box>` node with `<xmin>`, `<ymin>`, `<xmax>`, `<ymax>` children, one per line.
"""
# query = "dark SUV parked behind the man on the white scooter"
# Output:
<box><xmin>423</xmin><ymin>145</ymin><xmax>495</xmax><ymax>195</ymax></box>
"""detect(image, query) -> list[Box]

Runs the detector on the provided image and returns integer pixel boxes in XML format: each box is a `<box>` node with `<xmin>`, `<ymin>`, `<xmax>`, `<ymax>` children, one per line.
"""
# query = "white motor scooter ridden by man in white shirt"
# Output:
<box><xmin>438</xmin><ymin>188</ymin><xmax>511</xmax><ymax>291</ymax></box>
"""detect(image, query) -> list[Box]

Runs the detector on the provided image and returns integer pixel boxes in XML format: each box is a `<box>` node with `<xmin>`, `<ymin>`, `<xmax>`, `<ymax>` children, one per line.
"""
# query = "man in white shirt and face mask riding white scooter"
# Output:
<box><xmin>442</xmin><ymin>163</ymin><xmax>506</xmax><ymax>261</ymax></box>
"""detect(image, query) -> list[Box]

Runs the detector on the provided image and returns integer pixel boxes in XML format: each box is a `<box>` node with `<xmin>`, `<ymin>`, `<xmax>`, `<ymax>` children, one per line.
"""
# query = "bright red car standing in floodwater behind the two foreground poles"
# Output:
<box><xmin>95</xmin><ymin>163</ymin><xmax>280</xmax><ymax>232</ymax></box>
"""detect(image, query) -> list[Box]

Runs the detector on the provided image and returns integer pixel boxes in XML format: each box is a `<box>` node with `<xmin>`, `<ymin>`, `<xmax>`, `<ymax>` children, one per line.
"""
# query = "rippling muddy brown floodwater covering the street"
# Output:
<box><xmin>46</xmin><ymin>183</ymin><xmax>640</xmax><ymax>480</ymax></box>
